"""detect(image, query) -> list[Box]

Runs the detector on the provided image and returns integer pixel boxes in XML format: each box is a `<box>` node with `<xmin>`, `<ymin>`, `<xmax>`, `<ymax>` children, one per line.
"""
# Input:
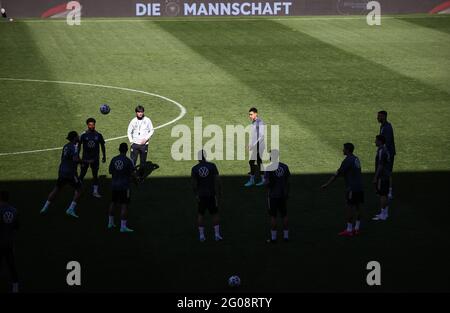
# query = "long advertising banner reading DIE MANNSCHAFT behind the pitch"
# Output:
<box><xmin>0</xmin><ymin>0</ymin><xmax>450</xmax><ymax>18</ymax></box>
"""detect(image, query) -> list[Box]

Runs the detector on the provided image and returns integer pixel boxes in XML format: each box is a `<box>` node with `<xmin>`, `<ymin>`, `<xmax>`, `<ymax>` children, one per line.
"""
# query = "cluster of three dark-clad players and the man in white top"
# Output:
<box><xmin>41</xmin><ymin>105</ymin><xmax>154</xmax><ymax>232</ymax></box>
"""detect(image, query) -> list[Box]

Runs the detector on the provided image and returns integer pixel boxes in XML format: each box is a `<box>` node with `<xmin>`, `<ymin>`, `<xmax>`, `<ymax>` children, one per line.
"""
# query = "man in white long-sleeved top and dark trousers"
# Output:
<box><xmin>128</xmin><ymin>105</ymin><xmax>155</xmax><ymax>178</ymax></box>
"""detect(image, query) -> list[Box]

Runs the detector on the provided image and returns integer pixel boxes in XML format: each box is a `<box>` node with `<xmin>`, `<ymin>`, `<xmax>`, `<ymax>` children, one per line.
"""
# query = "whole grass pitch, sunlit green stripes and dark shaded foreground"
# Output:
<box><xmin>0</xmin><ymin>15</ymin><xmax>450</xmax><ymax>292</ymax></box>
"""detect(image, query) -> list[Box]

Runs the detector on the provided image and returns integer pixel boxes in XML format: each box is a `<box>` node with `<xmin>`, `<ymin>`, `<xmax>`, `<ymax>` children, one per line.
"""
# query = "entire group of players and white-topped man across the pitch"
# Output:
<box><xmin>0</xmin><ymin>106</ymin><xmax>396</xmax><ymax>292</ymax></box>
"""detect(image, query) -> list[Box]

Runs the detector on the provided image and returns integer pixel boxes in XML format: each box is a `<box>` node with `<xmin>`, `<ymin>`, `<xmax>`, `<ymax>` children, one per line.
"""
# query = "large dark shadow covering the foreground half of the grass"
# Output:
<box><xmin>0</xmin><ymin>172</ymin><xmax>450</xmax><ymax>292</ymax></box>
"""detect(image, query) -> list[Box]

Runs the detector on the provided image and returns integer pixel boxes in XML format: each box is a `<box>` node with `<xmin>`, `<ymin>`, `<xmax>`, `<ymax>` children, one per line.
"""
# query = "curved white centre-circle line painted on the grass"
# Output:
<box><xmin>0</xmin><ymin>77</ymin><xmax>186</xmax><ymax>156</ymax></box>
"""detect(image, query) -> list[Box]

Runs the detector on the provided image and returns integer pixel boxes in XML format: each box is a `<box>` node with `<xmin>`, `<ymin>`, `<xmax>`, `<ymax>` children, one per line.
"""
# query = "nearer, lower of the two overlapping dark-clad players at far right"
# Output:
<box><xmin>373</xmin><ymin>135</ymin><xmax>392</xmax><ymax>221</ymax></box>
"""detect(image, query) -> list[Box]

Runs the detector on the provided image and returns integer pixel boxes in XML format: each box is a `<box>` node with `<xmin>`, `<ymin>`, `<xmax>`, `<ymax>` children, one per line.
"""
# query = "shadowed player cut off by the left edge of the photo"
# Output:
<box><xmin>0</xmin><ymin>191</ymin><xmax>19</xmax><ymax>293</ymax></box>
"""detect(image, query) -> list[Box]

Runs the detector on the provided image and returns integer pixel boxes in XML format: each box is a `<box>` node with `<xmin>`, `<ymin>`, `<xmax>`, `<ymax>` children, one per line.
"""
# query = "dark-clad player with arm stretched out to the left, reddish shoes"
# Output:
<box><xmin>321</xmin><ymin>143</ymin><xmax>364</xmax><ymax>237</ymax></box>
